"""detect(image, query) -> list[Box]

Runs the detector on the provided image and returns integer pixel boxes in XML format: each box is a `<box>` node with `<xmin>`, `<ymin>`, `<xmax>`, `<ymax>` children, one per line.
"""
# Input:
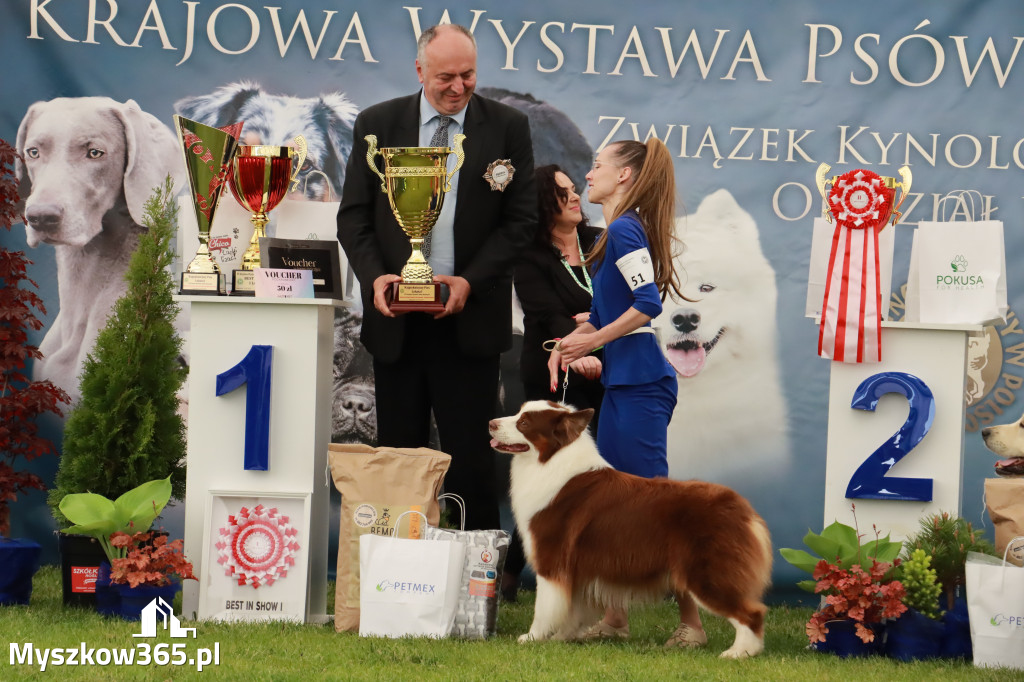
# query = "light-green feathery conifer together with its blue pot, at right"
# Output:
<box><xmin>904</xmin><ymin>512</ymin><xmax>997</xmax><ymax>658</ymax></box>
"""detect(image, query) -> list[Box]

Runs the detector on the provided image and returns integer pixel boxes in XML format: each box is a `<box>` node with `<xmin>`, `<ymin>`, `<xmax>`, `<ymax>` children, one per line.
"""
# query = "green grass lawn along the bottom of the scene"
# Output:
<box><xmin>0</xmin><ymin>566</ymin><xmax>1007</xmax><ymax>682</ymax></box>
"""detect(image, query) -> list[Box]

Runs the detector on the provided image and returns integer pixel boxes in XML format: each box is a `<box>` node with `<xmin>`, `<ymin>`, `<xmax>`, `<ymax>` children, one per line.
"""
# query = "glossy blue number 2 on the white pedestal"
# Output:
<box><xmin>846</xmin><ymin>372</ymin><xmax>935</xmax><ymax>502</ymax></box>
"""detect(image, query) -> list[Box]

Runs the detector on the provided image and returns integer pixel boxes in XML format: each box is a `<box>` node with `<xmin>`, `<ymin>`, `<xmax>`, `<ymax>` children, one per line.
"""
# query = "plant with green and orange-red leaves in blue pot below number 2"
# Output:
<box><xmin>779</xmin><ymin>507</ymin><xmax>906</xmax><ymax>656</ymax></box>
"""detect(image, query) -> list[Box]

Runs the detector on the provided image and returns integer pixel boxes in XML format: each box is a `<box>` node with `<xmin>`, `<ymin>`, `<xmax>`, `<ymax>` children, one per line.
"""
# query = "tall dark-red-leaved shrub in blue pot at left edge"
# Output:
<box><xmin>0</xmin><ymin>139</ymin><xmax>69</xmax><ymax>605</ymax></box>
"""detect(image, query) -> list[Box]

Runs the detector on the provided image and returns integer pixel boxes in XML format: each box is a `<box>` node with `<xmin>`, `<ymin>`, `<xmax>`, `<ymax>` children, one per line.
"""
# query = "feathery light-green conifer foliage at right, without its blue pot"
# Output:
<box><xmin>904</xmin><ymin>512</ymin><xmax>997</xmax><ymax>608</ymax></box>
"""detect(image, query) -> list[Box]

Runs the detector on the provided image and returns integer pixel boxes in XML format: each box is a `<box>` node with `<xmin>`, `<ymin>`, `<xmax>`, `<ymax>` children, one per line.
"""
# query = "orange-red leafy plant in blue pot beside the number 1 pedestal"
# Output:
<box><xmin>111</xmin><ymin>531</ymin><xmax>197</xmax><ymax>621</ymax></box>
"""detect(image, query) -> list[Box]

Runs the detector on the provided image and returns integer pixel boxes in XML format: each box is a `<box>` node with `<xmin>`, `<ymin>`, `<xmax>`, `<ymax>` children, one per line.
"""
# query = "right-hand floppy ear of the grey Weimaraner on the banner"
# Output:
<box><xmin>113</xmin><ymin>99</ymin><xmax>184</xmax><ymax>224</ymax></box>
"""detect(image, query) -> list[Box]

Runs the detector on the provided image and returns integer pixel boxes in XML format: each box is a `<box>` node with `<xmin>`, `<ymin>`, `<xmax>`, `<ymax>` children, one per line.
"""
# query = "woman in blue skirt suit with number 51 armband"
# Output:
<box><xmin>548</xmin><ymin>138</ymin><xmax>708</xmax><ymax>646</ymax></box>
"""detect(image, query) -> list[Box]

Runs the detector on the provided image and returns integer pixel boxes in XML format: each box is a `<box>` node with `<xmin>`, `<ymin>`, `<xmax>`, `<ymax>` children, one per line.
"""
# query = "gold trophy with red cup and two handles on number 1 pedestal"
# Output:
<box><xmin>230</xmin><ymin>135</ymin><xmax>306</xmax><ymax>296</ymax></box>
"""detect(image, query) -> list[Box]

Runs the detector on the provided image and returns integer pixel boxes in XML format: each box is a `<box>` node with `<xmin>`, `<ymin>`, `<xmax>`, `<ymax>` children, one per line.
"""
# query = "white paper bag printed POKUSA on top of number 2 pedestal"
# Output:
<box><xmin>907</xmin><ymin>220</ymin><xmax>1009</xmax><ymax>325</ymax></box>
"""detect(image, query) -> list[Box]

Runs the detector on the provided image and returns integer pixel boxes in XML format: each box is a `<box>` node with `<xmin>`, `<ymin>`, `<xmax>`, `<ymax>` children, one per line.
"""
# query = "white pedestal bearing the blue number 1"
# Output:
<box><xmin>175</xmin><ymin>296</ymin><xmax>346</xmax><ymax>622</ymax></box>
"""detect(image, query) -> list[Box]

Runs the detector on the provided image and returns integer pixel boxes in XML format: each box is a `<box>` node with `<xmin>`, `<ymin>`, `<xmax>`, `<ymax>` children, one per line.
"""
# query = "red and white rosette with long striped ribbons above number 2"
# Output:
<box><xmin>818</xmin><ymin>169</ymin><xmax>895</xmax><ymax>363</ymax></box>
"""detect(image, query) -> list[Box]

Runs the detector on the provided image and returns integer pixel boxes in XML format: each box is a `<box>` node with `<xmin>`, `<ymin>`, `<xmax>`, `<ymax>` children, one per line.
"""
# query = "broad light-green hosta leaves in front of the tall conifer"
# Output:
<box><xmin>60</xmin><ymin>476</ymin><xmax>171</xmax><ymax>566</ymax></box>
